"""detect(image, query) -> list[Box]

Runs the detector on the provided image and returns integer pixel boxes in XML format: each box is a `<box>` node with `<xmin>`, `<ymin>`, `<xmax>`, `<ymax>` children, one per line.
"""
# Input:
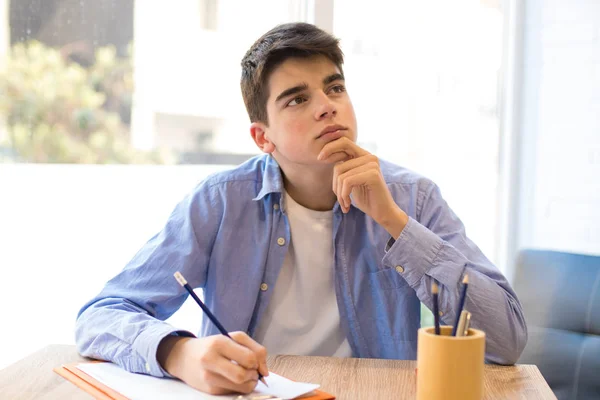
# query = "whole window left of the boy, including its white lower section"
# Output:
<box><xmin>0</xmin><ymin>0</ymin><xmax>314</xmax><ymax>368</ymax></box>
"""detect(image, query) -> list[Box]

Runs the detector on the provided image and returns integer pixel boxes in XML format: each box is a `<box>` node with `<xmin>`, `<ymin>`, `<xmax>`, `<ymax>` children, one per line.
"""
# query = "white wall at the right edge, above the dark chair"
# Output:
<box><xmin>517</xmin><ymin>0</ymin><xmax>600</xmax><ymax>254</ymax></box>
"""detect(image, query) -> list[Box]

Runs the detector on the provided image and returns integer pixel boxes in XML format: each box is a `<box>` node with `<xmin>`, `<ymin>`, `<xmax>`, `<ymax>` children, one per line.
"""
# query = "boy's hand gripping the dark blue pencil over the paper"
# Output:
<box><xmin>157</xmin><ymin>332</ymin><xmax>269</xmax><ymax>395</ymax></box>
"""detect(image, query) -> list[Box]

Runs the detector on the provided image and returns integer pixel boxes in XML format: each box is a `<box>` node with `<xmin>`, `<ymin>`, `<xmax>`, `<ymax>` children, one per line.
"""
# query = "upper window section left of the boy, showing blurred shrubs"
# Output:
<box><xmin>0</xmin><ymin>0</ymin><xmax>304</xmax><ymax>164</ymax></box>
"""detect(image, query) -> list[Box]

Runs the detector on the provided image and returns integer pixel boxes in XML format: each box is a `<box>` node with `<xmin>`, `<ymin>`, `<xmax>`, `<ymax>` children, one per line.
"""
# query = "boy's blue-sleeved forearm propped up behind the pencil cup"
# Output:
<box><xmin>384</xmin><ymin>220</ymin><xmax>527</xmax><ymax>364</ymax></box>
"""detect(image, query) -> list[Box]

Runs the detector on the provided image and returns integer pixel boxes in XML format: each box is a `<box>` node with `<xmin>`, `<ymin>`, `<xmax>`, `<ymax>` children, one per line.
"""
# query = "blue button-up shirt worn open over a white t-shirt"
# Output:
<box><xmin>76</xmin><ymin>155</ymin><xmax>527</xmax><ymax>376</ymax></box>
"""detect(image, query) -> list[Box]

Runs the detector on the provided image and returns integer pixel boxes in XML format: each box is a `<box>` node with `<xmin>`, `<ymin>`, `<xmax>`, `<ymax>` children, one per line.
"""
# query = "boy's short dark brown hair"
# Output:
<box><xmin>240</xmin><ymin>22</ymin><xmax>344</xmax><ymax>124</ymax></box>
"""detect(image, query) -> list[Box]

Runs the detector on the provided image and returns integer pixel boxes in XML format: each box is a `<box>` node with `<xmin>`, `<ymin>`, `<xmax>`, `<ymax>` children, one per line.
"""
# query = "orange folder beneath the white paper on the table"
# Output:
<box><xmin>53</xmin><ymin>361</ymin><xmax>335</xmax><ymax>400</ymax></box>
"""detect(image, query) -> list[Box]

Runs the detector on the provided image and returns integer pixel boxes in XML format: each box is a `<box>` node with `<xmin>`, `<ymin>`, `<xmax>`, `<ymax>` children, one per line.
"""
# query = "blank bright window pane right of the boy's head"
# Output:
<box><xmin>333</xmin><ymin>0</ymin><xmax>503</xmax><ymax>260</ymax></box>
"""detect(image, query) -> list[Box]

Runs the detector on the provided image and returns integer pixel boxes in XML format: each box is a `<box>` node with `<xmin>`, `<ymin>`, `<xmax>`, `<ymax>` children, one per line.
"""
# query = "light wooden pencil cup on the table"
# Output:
<box><xmin>417</xmin><ymin>326</ymin><xmax>485</xmax><ymax>400</ymax></box>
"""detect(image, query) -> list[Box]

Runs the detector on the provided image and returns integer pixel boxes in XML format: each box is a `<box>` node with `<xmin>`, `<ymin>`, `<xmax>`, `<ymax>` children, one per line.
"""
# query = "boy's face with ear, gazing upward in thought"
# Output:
<box><xmin>250</xmin><ymin>56</ymin><xmax>356</xmax><ymax>167</ymax></box>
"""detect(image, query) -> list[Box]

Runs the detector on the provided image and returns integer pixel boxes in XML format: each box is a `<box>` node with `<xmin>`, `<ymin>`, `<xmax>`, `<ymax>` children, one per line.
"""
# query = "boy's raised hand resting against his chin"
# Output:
<box><xmin>318</xmin><ymin>137</ymin><xmax>408</xmax><ymax>238</ymax></box>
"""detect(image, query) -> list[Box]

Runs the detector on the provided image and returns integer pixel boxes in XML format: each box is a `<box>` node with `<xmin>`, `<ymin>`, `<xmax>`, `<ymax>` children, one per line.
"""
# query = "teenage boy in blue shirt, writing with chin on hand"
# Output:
<box><xmin>76</xmin><ymin>23</ymin><xmax>527</xmax><ymax>394</ymax></box>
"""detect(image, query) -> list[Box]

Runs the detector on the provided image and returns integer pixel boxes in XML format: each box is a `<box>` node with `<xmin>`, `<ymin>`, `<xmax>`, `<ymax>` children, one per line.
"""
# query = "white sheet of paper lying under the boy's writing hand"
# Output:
<box><xmin>77</xmin><ymin>363</ymin><xmax>319</xmax><ymax>400</ymax></box>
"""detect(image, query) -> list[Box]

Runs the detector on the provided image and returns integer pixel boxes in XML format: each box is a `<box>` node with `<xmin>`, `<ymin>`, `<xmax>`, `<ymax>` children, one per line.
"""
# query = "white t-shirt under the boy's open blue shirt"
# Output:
<box><xmin>254</xmin><ymin>192</ymin><xmax>352</xmax><ymax>357</ymax></box>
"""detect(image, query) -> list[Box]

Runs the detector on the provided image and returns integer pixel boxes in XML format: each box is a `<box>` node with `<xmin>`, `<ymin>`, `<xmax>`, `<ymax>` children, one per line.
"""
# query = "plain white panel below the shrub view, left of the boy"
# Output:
<box><xmin>0</xmin><ymin>164</ymin><xmax>232</xmax><ymax>369</ymax></box>
